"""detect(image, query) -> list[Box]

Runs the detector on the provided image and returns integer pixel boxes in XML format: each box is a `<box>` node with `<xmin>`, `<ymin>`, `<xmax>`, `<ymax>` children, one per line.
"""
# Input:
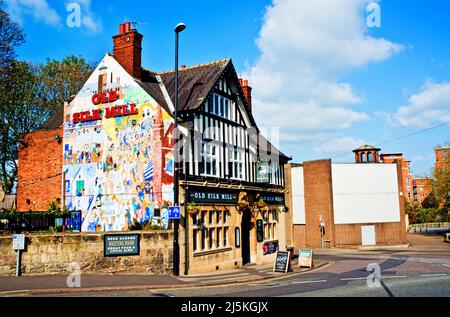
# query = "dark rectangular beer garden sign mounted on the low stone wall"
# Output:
<box><xmin>104</xmin><ymin>234</ymin><xmax>140</xmax><ymax>256</ymax></box>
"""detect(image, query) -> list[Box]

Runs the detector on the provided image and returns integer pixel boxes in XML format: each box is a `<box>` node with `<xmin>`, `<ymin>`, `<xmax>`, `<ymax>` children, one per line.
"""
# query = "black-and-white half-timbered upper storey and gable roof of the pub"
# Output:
<box><xmin>160</xmin><ymin>59</ymin><xmax>289</xmax><ymax>186</ymax></box>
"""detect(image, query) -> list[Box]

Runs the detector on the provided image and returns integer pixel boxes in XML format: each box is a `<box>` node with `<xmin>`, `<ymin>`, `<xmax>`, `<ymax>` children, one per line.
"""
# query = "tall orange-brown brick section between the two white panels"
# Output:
<box><xmin>303</xmin><ymin>160</ymin><xmax>334</xmax><ymax>248</ymax></box>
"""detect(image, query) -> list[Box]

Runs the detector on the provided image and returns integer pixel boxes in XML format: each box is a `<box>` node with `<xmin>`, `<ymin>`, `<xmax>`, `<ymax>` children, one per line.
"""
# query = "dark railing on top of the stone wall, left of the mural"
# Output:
<box><xmin>0</xmin><ymin>211</ymin><xmax>81</xmax><ymax>232</ymax></box>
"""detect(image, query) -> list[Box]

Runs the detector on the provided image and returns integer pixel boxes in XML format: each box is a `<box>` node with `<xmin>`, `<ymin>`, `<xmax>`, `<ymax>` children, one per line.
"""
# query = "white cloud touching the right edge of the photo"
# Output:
<box><xmin>383</xmin><ymin>80</ymin><xmax>450</xmax><ymax>127</ymax></box>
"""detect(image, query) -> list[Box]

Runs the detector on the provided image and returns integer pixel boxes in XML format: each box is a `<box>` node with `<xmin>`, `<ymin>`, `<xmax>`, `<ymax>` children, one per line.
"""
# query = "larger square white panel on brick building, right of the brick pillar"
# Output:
<box><xmin>332</xmin><ymin>164</ymin><xmax>400</xmax><ymax>224</ymax></box>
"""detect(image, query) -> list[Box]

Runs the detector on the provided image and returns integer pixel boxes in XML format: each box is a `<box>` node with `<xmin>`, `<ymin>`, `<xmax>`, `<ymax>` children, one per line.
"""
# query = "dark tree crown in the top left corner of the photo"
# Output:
<box><xmin>0</xmin><ymin>1</ymin><xmax>25</xmax><ymax>74</ymax></box>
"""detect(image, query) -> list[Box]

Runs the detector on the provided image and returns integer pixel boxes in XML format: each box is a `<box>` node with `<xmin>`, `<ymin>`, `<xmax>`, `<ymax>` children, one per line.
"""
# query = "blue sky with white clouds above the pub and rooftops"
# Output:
<box><xmin>4</xmin><ymin>0</ymin><xmax>450</xmax><ymax>176</ymax></box>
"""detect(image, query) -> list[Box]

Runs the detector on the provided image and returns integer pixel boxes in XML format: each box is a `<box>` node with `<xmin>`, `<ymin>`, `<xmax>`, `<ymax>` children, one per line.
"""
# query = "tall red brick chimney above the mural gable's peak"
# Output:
<box><xmin>113</xmin><ymin>22</ymin><xmax>143</xmax><ymax>79</ymax></box>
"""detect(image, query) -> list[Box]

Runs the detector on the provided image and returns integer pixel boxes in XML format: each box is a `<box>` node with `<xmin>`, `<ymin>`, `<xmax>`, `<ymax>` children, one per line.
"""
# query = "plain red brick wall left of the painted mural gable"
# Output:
<box><xmin>17</xmin><ymin>129</ymin><xmax>63</xmax><ymax>211</ymax></box>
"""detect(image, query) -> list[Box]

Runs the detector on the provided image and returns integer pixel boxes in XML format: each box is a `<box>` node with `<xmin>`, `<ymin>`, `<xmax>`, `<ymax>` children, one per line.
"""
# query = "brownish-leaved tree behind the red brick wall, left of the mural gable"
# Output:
<box><xmin>0</xmin><ymin>56</ymin><xmax>93</xmax><ymax>193</ymax></box>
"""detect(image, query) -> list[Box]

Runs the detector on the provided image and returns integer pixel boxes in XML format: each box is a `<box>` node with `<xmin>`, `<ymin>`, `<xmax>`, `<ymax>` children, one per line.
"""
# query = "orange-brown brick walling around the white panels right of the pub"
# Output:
<box><xmin>285</xmin><ymin>160</ymin><xmax>407</xmax><ymax>248</ymax></box>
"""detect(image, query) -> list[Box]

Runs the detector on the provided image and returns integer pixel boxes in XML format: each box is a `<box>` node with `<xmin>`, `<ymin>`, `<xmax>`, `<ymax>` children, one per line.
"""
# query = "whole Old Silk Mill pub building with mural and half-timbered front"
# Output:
<box><xmin>18</xmin><ymin>22</ymin><xmax>292</xmax><ymax>274</ymax></box>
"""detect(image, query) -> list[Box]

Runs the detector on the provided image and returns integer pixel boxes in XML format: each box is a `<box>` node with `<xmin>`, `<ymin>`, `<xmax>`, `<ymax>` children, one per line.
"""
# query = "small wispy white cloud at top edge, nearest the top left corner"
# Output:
<box><xmin>5</xmin><ymin>0</ymin><xmax>61</xmax><ymax>26</ymax></box>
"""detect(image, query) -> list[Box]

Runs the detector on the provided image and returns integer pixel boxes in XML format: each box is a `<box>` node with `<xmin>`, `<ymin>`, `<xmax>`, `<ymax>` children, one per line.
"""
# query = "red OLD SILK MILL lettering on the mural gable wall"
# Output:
<box><xmin>72</xmin><ymin>90</ymin><xmax>139</xmax><ymax>124</ymax></box>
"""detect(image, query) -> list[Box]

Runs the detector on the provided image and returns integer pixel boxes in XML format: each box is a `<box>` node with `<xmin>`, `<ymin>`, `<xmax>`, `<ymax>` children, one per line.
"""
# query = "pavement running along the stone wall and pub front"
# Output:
<box><xmin>0</xmin><ymin>259</ymin><xmax>329</xmax><ymax>296</ymax></box>
